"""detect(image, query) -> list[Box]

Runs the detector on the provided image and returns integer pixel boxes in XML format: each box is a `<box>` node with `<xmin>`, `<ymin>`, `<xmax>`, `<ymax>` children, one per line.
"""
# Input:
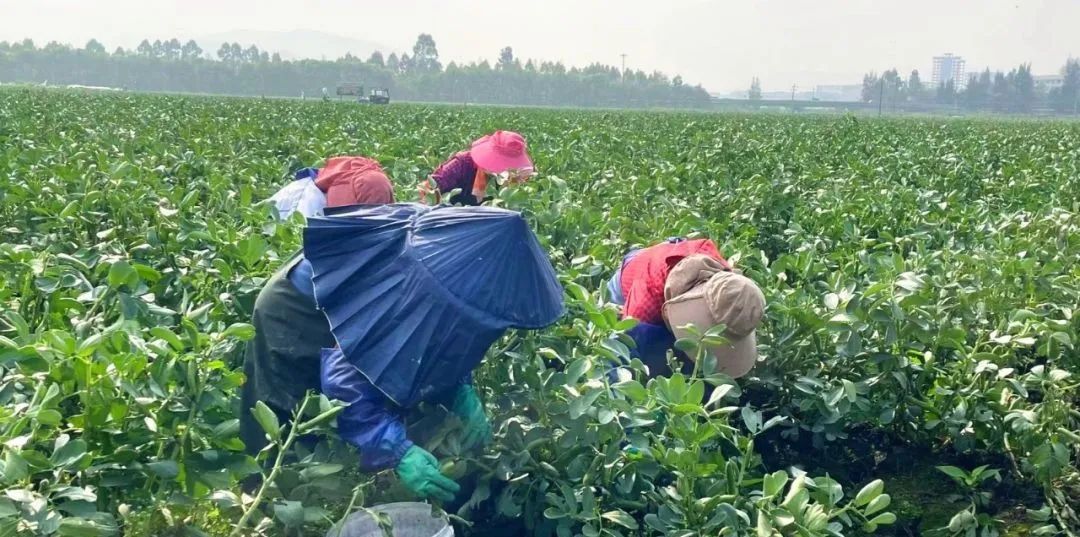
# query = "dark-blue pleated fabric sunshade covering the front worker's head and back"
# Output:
<box><xmin>303</xmin><ymin>203</ymin><xmax>564</xmax><ymax>406</ymax></box>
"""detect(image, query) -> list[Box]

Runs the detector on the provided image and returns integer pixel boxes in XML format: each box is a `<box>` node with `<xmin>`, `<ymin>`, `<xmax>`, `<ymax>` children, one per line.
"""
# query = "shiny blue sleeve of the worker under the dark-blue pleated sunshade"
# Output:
<box><xmin>320</xmin><ymin>348</ymin><xmax>413</xmax><ymax>472</ymax></box>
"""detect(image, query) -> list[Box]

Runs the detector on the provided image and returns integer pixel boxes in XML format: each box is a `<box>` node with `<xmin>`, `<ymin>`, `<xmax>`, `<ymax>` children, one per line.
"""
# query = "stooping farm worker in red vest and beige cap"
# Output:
<box><xmin>608</xmin><ymin>239</ymin><xmax>765</xmax><ymax>378</ymax></box>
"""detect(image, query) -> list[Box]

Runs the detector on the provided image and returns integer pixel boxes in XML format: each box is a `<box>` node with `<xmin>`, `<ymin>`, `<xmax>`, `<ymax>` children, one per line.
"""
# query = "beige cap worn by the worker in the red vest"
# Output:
<box><xmin>663</xmin><ymin>266</ymin><xmax>765</xmax><ymax>377</ymax></box>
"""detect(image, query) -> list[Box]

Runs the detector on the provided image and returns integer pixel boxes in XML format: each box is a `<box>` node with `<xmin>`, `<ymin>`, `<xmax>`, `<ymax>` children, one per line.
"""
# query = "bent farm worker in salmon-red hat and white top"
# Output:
<box><xmin>270</xmin><ymin>157</ymin><xmax>394</xmax><ymax>220</ymax></box>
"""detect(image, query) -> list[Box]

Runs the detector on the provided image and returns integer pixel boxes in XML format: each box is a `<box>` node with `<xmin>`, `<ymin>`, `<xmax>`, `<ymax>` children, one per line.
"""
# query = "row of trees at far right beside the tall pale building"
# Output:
<box><xmin>862</xmin><ymin>59</ymin><xmax>1080</xmax><ymax>113</ymax></box>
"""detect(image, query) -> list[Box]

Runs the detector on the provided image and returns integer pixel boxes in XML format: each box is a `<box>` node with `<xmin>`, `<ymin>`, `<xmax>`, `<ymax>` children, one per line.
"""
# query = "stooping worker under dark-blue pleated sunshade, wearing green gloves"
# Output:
<box><xmin>241</xmin><ymin>202</ymin><xmax>564</xmax><ymax>500</ymax></box>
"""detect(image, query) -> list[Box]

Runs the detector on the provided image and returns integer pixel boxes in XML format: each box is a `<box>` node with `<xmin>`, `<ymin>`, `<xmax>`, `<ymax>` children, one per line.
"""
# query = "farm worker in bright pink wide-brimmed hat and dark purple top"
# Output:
<box><xmin>419</xmin><ymin>131</ymin><xmax>534</xmax><ymax>205</ymax></box>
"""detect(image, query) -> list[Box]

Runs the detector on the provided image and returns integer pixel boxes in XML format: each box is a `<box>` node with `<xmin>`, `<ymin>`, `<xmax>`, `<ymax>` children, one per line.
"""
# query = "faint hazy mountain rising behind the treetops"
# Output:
<box><xmin>194</xmin><ymin>30</ymin><xmax>394</xmax><ymax>59</ymax></box>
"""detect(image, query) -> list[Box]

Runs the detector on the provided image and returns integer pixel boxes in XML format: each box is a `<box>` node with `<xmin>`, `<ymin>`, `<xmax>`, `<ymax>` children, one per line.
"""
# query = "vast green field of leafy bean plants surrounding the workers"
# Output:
<box><xmin>0</xmin><ymin>89</ymin><xmax>1080</xmax><ymax>537</ymax></box>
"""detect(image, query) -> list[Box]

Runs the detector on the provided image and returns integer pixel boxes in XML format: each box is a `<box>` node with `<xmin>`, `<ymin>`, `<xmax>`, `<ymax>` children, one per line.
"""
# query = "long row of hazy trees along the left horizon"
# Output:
<box><xmin>0</xmin><ymin>33</ymin><xmax>710</xmax><ymax>107</ymax></box>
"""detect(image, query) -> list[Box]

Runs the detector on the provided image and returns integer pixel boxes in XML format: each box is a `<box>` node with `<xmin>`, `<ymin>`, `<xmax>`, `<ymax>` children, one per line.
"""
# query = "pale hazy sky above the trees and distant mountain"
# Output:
<box><xmin>0</xmin><ymin>0</ymin><xmax>1080</xmax><ymax>92</ymax></box>
